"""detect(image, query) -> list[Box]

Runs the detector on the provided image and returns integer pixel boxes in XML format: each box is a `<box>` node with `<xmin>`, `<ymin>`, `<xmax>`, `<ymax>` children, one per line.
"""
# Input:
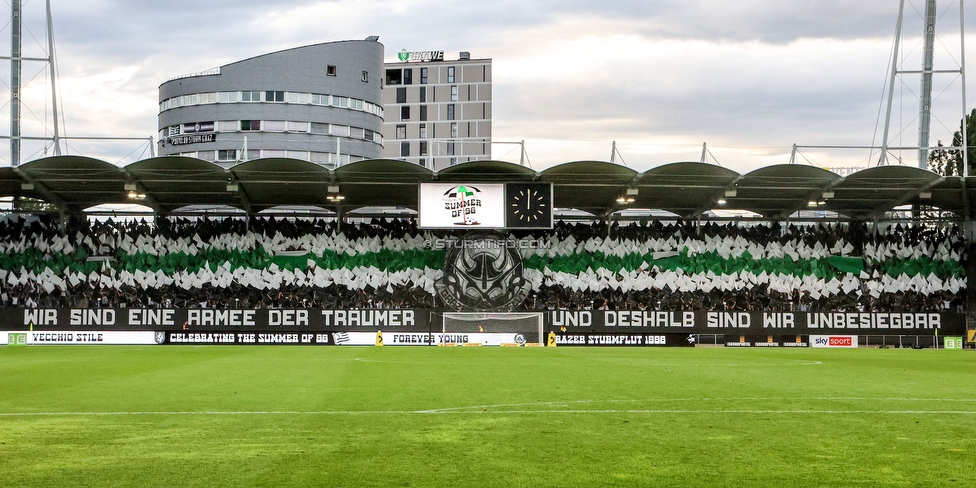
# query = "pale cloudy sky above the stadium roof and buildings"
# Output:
<box><xmin>0</xmin><ymin>0</ymin><xmax>976</xmax><ymax>172</ymax></box>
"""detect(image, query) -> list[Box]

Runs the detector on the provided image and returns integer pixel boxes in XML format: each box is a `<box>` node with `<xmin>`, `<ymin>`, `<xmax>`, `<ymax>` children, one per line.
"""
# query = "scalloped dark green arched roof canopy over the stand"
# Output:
<box><xmin>0</xmin><ymin>156</ymin><xmax>976</xmax><ymax>220</ymax></box>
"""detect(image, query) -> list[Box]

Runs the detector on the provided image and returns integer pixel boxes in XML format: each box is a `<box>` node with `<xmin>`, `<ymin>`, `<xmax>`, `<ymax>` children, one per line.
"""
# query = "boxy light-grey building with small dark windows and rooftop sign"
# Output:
<box><xmin>383</xmin><ymin>50</ymin><xmax>491</xmax><ymax>170</ymax></box>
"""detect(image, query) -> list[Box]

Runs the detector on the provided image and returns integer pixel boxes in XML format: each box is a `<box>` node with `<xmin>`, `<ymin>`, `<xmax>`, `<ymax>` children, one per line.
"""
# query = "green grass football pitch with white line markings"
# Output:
<box><xmin>0</xmin><ymin>346</ymin><xmax>976</xmax><ymax>488</ymax></box>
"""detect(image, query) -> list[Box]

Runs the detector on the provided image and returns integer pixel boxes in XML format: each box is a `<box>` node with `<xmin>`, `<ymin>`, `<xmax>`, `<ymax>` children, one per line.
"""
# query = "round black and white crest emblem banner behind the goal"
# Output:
<box><xmin>435</xmin><ymin>232</ymin><xmax>529</xmax><ymax>312</ymax></box>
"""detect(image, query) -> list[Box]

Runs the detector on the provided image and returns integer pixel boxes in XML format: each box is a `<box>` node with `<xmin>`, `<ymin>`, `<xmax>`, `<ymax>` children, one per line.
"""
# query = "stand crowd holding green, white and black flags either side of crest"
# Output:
<box><xmin>0</xmin><ymin>214</ymin><xmax>967</xmax><ymax>312</ymax></box>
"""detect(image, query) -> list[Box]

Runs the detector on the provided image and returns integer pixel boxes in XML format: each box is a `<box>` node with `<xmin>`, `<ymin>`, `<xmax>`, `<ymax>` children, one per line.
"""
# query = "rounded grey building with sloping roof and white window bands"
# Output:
<box><xmin>158</xmin><ymin>37</ymin><xmax>383</xmax><ymax>167</ymax></box>
